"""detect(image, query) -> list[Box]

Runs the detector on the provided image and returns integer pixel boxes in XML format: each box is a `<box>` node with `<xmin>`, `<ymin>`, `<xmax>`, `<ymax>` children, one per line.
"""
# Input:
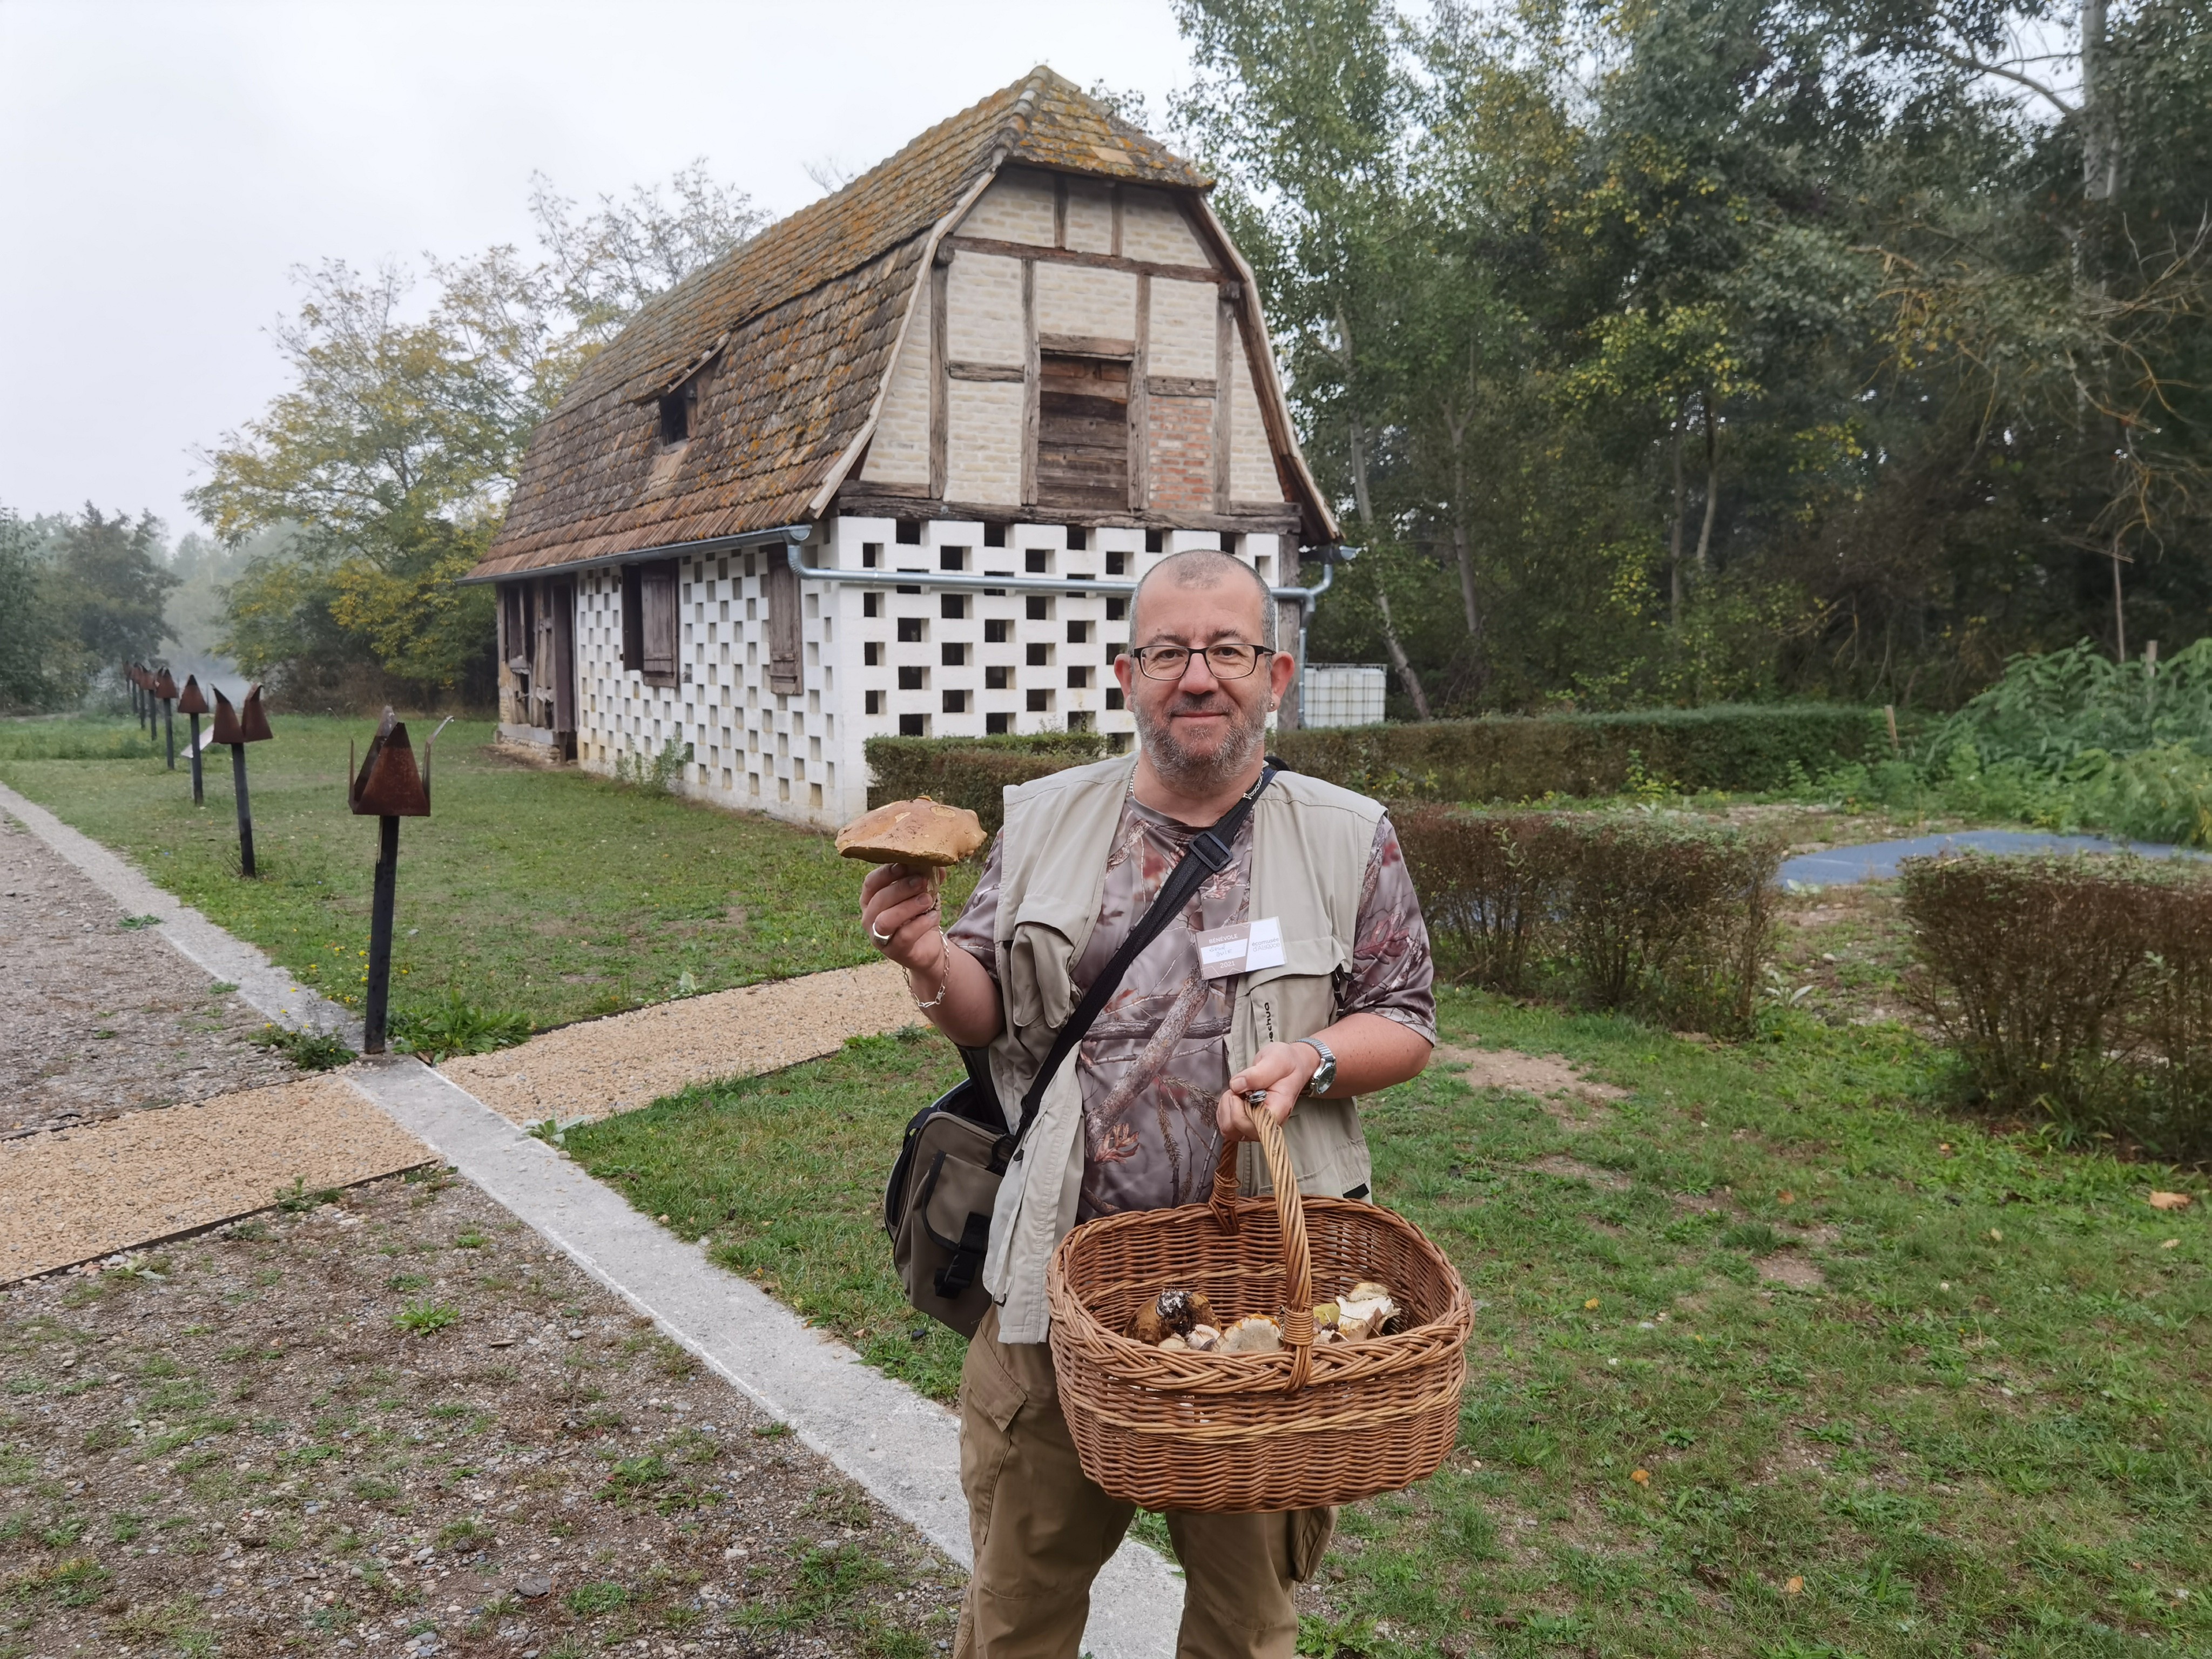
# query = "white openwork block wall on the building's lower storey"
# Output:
<box><xmin>575</xmin><ymin>517</ymin><xmax>1296</xmax><ymax>830</ymax></box>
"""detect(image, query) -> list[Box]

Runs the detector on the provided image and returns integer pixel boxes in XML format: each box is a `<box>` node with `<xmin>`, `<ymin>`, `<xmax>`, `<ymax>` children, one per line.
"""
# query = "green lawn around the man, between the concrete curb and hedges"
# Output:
<box><xmin>569</xmin><ymin>995</ymin><xmax>2212</xmax><ymax>1659</ymax></box>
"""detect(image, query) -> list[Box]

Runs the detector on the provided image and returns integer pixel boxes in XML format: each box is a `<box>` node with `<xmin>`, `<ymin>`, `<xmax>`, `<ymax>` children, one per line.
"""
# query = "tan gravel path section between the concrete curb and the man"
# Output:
<box><xmin>438</xmin><ymin>962</ymin><xmax>922</xmax><ymax>1124</ymax></box>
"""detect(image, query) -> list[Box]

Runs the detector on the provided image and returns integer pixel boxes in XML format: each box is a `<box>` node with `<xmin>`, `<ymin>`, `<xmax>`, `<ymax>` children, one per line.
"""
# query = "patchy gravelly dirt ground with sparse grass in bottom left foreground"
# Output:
<box><xmin>0</xmin><ymin>1175</ymin><xmax>960</xmax><ymax>1659</ymax></box>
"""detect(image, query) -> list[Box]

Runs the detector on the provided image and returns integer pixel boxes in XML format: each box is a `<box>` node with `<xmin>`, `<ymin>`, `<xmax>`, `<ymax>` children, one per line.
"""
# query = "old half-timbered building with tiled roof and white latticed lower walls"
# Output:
<box><xmin>467</xmin><ymin>69</ymin><xmax>1336</xmax><ymax>825</ymax></box>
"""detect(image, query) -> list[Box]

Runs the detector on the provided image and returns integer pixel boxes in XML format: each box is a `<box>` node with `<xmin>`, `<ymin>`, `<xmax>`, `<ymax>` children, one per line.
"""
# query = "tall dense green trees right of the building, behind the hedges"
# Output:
<box><xmin>1175</xmin><ymin>0</ymin><xmax>2212</xmax><ymax>717</ymax></box>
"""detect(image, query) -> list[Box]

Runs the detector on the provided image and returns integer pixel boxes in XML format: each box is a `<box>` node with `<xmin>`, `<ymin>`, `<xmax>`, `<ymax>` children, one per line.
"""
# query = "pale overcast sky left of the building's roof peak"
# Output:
<box><xmin>0</xmin><ymin>0</ymin><xmax>1188</xmax><ymax>533</ymax></box>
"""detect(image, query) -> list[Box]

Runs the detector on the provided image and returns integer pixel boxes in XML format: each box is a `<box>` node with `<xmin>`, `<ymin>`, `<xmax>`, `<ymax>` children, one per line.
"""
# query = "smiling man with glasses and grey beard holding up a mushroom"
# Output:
<box><xmin>860</xmin><ymin>553</ymin><xmax>1435</xmax><ymax>1659</ymax></box>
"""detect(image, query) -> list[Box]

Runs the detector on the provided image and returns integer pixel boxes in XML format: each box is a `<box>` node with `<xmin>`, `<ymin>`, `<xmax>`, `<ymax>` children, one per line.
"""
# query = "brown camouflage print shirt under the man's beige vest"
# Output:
<box><xmin>951</xmin><ymin>797</ymin><xmax>1435</xmax><ymax>1221</ymax></box>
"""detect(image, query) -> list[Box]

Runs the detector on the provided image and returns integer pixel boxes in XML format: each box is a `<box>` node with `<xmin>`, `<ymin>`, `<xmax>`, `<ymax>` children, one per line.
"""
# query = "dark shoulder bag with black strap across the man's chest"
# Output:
<box><xmin>882</xmin><ymin>759</ymin><xmax>1278</xmax><ymax>1336</ymax></box>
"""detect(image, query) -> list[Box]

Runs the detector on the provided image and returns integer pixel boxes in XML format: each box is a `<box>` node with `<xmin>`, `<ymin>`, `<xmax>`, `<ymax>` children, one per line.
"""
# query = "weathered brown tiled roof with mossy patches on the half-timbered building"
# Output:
<box><xmin>474</xmin><ymin>69</ymin><xmax>1208</xmax><ymax>577</ymax></box>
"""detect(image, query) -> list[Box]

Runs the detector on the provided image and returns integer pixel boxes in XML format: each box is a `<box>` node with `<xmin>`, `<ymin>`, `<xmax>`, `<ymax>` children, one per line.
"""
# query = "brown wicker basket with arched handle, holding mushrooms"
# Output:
<box><xmin>1046</xmin><ymin>1112</ymin><xmax>1473</xmax><ymax>1511</ymax></box>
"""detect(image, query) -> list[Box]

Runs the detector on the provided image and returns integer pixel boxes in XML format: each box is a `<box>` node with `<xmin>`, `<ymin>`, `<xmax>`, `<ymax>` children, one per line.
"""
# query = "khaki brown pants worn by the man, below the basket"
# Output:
<box><xmin>953</xmin><ymin>1307</ymin><xmax>1336</xmax><ymax>1659</ymax></box>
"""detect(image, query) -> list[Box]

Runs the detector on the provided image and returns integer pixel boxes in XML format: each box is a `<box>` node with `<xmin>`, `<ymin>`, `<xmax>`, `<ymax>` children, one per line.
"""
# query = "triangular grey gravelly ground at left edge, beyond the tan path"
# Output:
<box><xmin>0</xmin><ymin>814</ymin><xmax>299</xmax><ymax>1137</ymax></box>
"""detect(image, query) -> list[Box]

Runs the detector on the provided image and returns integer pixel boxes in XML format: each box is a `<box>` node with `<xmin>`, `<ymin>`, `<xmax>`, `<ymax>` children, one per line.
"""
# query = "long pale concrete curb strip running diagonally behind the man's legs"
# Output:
<box><xmin>0</xmin><ymin>785</ymin><xmax>1183</xmax><ymax>1659</ymax></box>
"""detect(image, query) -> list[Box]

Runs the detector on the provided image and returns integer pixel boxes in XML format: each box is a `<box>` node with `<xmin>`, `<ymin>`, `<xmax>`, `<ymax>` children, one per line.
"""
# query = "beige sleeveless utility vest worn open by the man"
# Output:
<box><xmin>982</xmin><ymin>757</ymin><xmax>1382</xmax><ymax>1343</ymax></box>
